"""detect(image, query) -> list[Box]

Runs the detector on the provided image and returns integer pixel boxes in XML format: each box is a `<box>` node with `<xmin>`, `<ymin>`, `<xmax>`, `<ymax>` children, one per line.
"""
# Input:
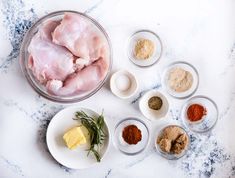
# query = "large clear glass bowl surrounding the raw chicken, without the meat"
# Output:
<box><xmin>20</xmin><ymin>10</ymin><xmax>112</xmax><ymax>103</ymax></box>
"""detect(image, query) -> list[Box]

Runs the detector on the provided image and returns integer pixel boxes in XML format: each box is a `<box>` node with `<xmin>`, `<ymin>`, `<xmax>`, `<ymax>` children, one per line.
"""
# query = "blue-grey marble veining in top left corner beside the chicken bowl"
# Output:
<box><xmin>0</xmin><ymin>0</ymin><xmax>37</xmax><ymax>72</ymax></box>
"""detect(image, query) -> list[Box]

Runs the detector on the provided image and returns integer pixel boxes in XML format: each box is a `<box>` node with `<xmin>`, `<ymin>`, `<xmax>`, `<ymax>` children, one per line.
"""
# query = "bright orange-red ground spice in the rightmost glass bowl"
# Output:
<box><xmin>187</xmin><ymin>104</ymin><xmax>207</xmax><ymax>122</ymax></box>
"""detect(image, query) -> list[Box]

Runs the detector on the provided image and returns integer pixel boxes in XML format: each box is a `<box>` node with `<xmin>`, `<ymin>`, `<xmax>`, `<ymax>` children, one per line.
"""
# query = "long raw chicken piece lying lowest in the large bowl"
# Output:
<box><xmin>46</xmin><ymin>58</ymin><xmax>108</xmax><ymax>96</ymax></box>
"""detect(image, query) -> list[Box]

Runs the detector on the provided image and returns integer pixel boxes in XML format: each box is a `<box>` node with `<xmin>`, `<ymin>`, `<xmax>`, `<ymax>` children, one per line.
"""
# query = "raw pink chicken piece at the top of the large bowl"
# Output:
<box><xmin>52</xmin><ymin>13</ymin><xmax>107</xmax><ymax>61</ymax></box>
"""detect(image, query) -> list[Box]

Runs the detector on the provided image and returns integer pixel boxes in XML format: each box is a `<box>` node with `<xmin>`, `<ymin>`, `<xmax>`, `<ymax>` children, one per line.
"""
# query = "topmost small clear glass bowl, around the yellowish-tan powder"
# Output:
<box><xmin>127</xmin><ymin>30</ymin><xmax>162</xmax><ymax>67</ymax></box>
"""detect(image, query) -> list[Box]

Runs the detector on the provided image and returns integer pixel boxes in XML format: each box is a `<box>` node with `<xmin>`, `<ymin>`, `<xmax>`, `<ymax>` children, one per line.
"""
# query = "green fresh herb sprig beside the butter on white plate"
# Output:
<box><xmin>74</xmin><ymin>111</ymin><xmax>106</xmax><ymax>162</ymax></box>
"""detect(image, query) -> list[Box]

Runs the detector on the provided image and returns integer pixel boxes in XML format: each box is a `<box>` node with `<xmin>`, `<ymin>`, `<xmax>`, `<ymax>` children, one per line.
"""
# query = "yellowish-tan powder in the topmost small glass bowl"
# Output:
<box><xmin>134</xmin><ymin>38</ymin><xmax>154</xmax><ymax>60</ymax></box>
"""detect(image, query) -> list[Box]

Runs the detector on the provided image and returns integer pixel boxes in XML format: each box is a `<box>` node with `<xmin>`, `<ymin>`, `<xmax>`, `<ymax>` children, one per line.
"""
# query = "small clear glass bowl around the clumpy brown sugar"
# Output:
<box><xmin>155</xmin><ymin>125</ymin><xmax>190</xmax><ymax>160</ymax></box>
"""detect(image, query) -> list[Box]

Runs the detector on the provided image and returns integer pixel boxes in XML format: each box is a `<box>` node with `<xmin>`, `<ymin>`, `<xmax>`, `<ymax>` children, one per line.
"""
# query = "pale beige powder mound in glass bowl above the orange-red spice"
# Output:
<box><xmin>168</xmin><ymin>67</ymin><xmax>193</xmax><ymax>93</ymax></box>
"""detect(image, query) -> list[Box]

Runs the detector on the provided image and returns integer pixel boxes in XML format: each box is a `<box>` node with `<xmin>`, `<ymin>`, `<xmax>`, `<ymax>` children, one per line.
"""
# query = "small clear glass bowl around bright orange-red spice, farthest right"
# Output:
<box><xmin>181</xmin><ymin>96</ymin><xmax>219</xmax><ymax>133</ymax></box>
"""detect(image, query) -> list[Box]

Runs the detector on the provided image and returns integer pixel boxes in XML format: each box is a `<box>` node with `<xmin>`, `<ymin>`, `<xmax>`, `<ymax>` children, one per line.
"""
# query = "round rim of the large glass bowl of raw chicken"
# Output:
<box><xmin>19</xmin><ymin>10</ymin><xmax>113</xmax><ymax>104</ymax></box>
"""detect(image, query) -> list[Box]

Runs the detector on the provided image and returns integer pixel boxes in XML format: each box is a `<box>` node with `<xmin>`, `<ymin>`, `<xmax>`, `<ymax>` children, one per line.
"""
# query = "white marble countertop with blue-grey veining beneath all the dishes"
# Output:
<box><xmin>0</xmin><ymin>0</ymin><xmax>235</xmax><ymax>178</ymax></box>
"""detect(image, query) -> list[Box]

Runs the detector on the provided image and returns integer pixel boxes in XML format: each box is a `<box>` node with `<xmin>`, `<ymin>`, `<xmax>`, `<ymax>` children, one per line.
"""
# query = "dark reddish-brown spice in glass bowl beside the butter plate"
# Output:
<box><xmin>122</xmin><ymin>125</ymin><xmax>142</xmax><ymax>145</ymax></box>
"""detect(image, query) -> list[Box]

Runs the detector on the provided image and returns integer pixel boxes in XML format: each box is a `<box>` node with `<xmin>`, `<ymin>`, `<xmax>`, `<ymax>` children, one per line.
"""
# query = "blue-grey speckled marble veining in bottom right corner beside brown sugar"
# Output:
<box><xmin>181</xmin><ymin>134</ymin><xmax>235</xmax><ymax>177</ymax></box>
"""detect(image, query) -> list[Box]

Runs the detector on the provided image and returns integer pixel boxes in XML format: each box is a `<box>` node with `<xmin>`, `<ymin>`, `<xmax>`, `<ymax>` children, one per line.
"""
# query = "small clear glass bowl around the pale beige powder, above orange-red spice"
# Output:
<box><xmin>162</xmin><ymin>61</ymin><xmax>199</xmax><ymax>99</ymax></box>
